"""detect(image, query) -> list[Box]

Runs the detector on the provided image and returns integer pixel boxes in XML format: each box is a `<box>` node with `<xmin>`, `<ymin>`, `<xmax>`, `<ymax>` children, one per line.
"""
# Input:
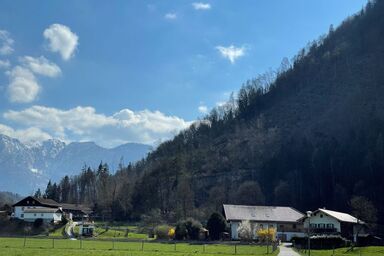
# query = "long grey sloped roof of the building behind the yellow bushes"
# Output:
<box><xmin>223</xmin><ymin>204</ymin><xmax>304</xmax><ymax>222</ymax></box>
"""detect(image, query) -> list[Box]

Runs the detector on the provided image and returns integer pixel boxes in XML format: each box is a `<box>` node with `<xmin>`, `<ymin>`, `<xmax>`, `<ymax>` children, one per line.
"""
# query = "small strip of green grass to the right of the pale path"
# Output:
<box><xmin>300</xmin><ymin>246</ymin><xmax>384</xmax><ymax>256</ymax></box>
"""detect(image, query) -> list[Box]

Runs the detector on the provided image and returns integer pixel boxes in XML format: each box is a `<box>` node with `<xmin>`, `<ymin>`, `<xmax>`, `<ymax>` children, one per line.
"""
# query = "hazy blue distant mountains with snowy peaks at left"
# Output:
<box><xmin>0</xmin><ymin>134</ymin><xmax>152</xmax><ymax>194</ymax></box>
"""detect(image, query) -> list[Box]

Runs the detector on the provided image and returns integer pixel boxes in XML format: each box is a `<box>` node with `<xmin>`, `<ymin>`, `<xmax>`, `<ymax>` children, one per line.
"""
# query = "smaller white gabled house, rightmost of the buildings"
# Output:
<box><xmin>303</xmin><ymin>208</ymin><xmax>367</xmax><ymax>241</ymax></box>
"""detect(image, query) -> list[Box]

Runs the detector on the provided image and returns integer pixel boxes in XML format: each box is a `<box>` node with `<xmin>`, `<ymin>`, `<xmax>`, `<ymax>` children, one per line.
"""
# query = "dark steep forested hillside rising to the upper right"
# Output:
<box><xmin>37</xmin><ymin>1</ymin><xmax>384</xmax><ymax>236</ymax></box>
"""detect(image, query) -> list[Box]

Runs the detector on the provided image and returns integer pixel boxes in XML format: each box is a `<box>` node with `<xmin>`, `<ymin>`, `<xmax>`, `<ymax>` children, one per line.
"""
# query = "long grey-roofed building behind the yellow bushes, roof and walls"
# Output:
<box><xmin>223</xmin><ymin>204</ymin><xmax>305</xmax><ymax>241</ymax></box>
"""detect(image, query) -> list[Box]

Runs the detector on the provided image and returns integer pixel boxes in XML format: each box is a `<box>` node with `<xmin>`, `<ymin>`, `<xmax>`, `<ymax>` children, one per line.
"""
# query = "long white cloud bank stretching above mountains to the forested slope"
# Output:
<box><xmin>3</xmin><ymin>106</ymin><xmax>191</xmax><ymax>147</ymax></box>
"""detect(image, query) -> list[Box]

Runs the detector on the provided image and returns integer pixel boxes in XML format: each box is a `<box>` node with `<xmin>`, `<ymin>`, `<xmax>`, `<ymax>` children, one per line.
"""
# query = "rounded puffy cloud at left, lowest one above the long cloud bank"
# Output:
<box><xmin>7</xmin><ymin>66</ymin><xmax>40</xmax><ymax>103</ymax></box>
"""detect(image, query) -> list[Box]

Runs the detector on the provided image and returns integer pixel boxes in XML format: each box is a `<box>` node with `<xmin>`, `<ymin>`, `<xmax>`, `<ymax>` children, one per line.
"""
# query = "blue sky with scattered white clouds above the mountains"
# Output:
<box><xmin>0</xmin><ymin>0</ymin><xmax>366</xmax><ymax>148</ymax></box>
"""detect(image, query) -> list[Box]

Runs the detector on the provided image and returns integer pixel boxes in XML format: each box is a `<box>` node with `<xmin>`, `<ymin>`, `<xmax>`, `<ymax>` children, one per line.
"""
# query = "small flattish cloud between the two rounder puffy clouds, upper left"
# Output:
<box><xmin>20</xmin><ymin>56</ymin><xmax>61</xmax><ymax>77</ymax></box>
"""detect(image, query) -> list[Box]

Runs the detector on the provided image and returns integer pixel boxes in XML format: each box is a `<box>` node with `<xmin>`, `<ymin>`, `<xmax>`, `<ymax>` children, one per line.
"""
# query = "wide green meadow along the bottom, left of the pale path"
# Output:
<box><xmin>0</xmin><ymin>238</ymin><xmax>277</xmax><ymax>256</ymax></box>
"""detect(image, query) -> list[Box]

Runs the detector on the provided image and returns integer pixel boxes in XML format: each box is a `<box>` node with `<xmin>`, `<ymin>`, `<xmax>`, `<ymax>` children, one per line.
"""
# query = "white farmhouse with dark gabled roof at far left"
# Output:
<box><xmin>12</xmin><ymin>196</ymin><xmax>63</xmax><ymax>223</ymax></box>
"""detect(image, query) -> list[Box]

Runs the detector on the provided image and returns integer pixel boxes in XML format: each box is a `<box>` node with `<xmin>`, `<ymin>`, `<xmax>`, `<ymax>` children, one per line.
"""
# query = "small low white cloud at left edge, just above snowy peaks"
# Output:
<box><xmin>0</xmin><ymin>124</ymin><xmax>52</xmax><ymax>143</ymax></box>
